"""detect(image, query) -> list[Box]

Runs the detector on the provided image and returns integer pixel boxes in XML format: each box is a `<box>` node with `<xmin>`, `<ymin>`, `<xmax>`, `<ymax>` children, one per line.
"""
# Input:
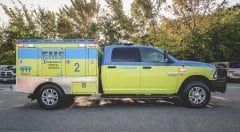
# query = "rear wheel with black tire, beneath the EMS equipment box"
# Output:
<box><xmin>37</xmin><ymin>84</ymin><xmax>64</xmax><ymax>110</ymax></box>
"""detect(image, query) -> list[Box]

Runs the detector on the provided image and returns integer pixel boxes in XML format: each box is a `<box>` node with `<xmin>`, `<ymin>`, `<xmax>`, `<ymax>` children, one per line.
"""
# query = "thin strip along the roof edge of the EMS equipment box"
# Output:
<box><xmin>17</xmin><ymin>39</ymin><xmax>96</xmax><ymax>44</ymax></box>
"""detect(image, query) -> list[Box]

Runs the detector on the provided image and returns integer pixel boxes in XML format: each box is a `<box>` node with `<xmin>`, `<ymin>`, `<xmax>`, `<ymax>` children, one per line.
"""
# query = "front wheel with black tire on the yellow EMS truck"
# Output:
<box><xmin>180</xmin><ymin>81</ymin><xmax>211</xmax><ymax>108</ymax></box>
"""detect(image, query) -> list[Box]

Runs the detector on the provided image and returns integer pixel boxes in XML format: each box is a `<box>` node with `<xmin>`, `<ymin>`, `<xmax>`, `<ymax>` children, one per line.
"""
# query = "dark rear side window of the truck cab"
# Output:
<box><xmin>111</xmin><ymin>48</ymin><xmax>141</xmax><ymax>62</ymax></box>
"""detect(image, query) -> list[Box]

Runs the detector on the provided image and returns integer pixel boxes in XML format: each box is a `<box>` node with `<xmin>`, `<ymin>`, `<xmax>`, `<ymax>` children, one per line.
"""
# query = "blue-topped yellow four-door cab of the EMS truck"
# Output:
<box><xmin>102</xmin><ymin>45</ymin><xmax>179</xmax><ymax>95</ymax></box>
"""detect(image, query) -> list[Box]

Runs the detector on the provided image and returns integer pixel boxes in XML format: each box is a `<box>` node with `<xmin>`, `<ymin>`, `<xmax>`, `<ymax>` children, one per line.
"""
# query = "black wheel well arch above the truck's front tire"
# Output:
<box><xmin>178</xmin><ymin>75</ymin><xmax>212</xmax><ymax>94</ymax></box>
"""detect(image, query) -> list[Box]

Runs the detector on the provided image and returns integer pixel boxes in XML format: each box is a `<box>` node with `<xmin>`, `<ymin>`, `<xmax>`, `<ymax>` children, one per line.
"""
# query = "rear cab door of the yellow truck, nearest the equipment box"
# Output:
<box><xmin>103</xmin><ymin>47</ymin><xmax>144</xmax><ymax>94</ymax></box>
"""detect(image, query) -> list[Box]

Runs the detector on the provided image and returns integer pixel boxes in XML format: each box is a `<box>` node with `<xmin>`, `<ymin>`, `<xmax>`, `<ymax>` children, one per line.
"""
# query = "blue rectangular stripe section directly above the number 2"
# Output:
<box><xmin>65</xmin><ymin>48</ymin><xmax>86</xmax><ymax>59</ymax></box>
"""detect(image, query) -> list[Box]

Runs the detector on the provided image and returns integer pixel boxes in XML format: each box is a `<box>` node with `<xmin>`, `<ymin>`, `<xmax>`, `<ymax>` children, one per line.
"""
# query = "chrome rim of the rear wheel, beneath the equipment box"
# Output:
<box><xmin>41</xmin><ymin>88</ymin><xmax>58</xmax><ymax>105</ymax></box>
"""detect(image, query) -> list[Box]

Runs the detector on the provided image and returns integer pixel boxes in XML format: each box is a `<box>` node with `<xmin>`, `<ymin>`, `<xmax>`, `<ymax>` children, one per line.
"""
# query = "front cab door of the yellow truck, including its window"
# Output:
<box><xmin>140</xmin><ymin>47</ymin><xmax>178</xmax><ymax>94</ymax></box>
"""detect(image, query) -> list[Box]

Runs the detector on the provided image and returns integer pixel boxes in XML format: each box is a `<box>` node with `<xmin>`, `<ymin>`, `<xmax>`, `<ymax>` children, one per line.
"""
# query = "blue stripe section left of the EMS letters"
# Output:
<box><xmin>18</xmin><ymin>48</ymin><xmax>40</xmax><ymax>59</ymax></box>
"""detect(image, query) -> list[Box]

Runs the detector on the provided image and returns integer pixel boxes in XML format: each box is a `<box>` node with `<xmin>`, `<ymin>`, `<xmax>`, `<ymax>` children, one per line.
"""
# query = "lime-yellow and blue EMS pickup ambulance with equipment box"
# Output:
<box><xmin>16</xmin><ymin>39</ymin><xmax>226</xmax><ymax>110</ymax></box>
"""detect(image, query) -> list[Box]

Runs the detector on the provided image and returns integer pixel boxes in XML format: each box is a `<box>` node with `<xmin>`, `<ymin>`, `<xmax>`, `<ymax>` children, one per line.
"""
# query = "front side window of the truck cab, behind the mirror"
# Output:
<box><xmin>140</xmin><ymin>48</ymin><xmax>164</xmax><ymax>63</ymax></box>
